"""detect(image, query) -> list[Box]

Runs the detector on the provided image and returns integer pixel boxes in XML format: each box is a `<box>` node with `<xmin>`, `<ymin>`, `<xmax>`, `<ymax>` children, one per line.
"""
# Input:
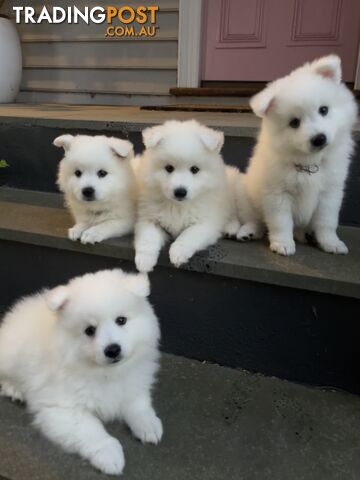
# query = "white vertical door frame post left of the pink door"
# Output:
<box><xmin>177</xmin><ymin>0</ymin><xmax>204</xmax><ymax>88</ymax></box>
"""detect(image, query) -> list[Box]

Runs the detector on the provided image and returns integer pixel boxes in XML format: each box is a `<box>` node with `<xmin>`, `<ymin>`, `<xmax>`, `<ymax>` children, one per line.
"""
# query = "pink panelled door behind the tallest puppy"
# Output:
<box><xmin>202</xmin><ymin>0</ymin><xmax>360</xmax><ymax>82</ymax></box>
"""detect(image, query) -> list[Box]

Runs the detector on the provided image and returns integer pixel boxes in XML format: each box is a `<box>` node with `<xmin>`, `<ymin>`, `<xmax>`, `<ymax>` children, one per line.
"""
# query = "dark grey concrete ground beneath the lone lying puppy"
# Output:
<box><xmin>0</xmin><ymin>355</ymin><xmax>360</xmax><ymax>480</ymax></box>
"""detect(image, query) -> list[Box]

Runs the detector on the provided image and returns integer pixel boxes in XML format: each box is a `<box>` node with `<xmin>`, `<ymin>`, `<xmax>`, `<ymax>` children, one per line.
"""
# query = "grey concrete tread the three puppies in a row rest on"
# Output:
<box><xmin>0</xmin><ymin>188</ymin><xmax>360</xmax><ymax>298</ymax></box>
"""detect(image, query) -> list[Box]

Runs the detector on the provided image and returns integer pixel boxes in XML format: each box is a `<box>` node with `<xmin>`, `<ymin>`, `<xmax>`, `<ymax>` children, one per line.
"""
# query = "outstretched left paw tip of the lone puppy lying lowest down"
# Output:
<box><xmin>90</xmin><ymin>438</ymin><xmax>125</xmax><ymax>475</ymax></box>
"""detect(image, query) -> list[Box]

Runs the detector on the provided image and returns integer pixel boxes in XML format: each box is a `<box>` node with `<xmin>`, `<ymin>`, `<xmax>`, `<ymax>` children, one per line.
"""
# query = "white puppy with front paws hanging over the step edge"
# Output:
<box><xmin>135</xmin><ymin>120</ymin><xmax>235</xmax><ymax>272</ymax></box>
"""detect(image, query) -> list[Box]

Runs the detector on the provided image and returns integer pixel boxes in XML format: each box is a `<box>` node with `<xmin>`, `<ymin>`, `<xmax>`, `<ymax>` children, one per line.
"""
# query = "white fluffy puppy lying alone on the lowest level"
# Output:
<box><xmin>0</xmin><ymin>270</ymin><xmax>162</xmax><ymax>474</ymax></box>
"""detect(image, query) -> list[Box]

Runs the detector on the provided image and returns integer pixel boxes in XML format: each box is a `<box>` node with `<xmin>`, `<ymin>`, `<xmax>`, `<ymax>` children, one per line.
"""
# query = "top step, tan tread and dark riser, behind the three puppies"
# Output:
<box><xmin>0</xmin><ymin>101</ymin><xmax>360</xmax><ymax>226</ymax></box>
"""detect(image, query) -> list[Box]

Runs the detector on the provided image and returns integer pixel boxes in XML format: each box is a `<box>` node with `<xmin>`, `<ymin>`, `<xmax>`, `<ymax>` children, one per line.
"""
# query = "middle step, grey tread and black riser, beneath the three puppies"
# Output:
<box><xmin>0</xmin><ymin>188</ymin><xmax>360</xmax><ymax>392</ymax></box>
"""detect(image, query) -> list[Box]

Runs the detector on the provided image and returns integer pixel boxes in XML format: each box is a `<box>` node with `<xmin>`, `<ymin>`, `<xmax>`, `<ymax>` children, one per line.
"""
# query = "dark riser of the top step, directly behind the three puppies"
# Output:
<box><xmin>0</xmin><ymin>124</ymin><xmax>360</xmax><ymax>226</ymax></box>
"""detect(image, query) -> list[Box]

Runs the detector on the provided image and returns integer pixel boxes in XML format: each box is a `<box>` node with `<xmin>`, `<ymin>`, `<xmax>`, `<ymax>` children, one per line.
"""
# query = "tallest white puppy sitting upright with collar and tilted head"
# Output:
<box><xmin>240</xmin><ymin>55</ymin><xmax>357</xmax><ymax>255</ymax></box>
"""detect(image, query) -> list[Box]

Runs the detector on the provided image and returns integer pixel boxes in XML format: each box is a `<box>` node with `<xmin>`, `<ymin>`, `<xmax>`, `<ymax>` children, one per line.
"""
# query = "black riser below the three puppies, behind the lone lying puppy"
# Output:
<box><xmin>0</xmin><ymin>241</ymin><xmax>360</xmax><ymax>393</ymax></box>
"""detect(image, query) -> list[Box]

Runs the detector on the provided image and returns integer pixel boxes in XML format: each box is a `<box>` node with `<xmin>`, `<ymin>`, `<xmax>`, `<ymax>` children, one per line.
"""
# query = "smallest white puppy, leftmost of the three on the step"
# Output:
<box><xmin>54</xmin><ymin>135</ymin><xmax>136</xmax><ymax>243</ymax></box>
